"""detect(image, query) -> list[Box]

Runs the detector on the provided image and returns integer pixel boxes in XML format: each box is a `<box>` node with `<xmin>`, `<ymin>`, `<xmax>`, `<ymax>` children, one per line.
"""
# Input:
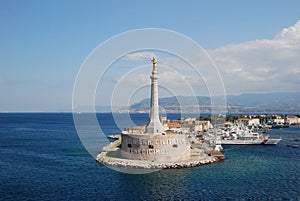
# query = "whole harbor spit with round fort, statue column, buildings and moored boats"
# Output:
<box><xmin>96</xmin><ymin>57</ymin><xmax>292</xmax><ymax>169</ymax></box>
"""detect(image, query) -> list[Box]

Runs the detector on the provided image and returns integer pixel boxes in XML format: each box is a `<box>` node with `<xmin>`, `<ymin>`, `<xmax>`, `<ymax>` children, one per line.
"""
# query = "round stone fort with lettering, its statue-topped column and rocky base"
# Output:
<box><xmin>97</xmin><ymin>57</ymin><xmax>224</xmax><ymax>168</ymax></box>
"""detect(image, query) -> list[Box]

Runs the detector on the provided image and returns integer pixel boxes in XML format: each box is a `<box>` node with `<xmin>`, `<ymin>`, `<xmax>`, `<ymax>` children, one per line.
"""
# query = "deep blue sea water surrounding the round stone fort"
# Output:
<box><xmin>0</xmin><ymin>113</ymin><xmax>300</xmax><ymax>200</ymax></box>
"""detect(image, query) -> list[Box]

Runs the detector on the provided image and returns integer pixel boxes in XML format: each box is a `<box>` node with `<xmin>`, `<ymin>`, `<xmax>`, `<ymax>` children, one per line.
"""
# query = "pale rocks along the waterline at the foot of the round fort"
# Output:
<box><xmin>96</xmin><ymin>140</ymin><xmax>224</xmax><ymax>169</ymax></box>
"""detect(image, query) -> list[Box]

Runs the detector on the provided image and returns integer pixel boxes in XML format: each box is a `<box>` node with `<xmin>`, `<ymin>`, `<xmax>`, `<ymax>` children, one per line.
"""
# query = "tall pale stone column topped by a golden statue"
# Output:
<box><xmin>146</xmin><ymin>57</ymin><xmax>164</xmax><ymax>134</ymax></box>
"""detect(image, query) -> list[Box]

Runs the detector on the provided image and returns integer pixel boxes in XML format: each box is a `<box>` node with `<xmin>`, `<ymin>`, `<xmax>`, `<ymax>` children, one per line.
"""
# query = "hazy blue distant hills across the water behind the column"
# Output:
<box><xmin>129</xmin><ymin>92</ymin><xmax>300</xmax><ymax>113</ymax></box>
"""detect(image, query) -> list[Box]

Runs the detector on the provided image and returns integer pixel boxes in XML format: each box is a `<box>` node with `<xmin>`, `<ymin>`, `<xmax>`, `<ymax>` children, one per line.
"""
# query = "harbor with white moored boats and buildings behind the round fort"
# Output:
<box><xmin>107</xmin><ymin>115</ymin><xmax>288</xmax><ymax>146</ymax></box>
